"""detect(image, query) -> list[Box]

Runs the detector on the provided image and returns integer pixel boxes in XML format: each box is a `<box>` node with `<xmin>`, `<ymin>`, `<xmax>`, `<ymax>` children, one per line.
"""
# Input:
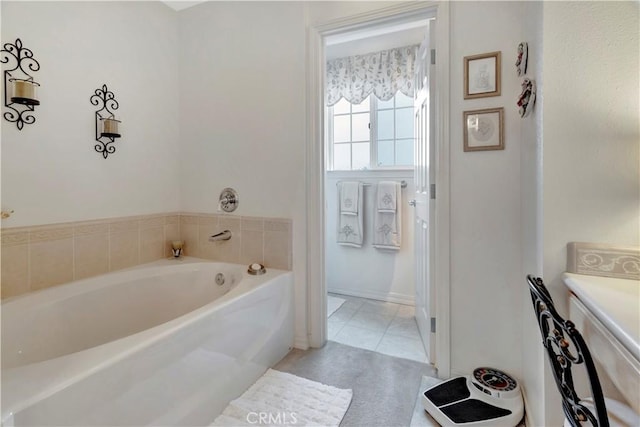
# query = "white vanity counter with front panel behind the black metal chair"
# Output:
<box><xmin>563</xmin><ymin>273</ymin><xmax>640</xmax><ymax>413</ymax></box>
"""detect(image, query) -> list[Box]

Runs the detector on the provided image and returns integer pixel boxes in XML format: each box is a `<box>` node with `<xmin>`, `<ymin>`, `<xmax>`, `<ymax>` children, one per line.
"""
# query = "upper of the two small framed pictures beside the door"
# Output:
<box><xmin>464</xmin><ymin>52</ymin><xmax>500</xmax><ymax>99</ymax></box>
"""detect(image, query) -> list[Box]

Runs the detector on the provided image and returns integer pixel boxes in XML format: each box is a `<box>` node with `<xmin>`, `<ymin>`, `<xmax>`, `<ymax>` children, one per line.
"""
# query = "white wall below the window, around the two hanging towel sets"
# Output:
<box><xmin>325</xmin><ymin>171</ymin><xmax>415</xmax><ymax>304</ymax></box>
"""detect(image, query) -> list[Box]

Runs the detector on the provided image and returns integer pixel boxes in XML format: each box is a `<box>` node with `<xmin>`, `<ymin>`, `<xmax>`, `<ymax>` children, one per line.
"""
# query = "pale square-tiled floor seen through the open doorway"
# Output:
<box><xmin>328</xmin><ymin>294</ymin><xmax>429</xmax><ymax>363</ymax></box>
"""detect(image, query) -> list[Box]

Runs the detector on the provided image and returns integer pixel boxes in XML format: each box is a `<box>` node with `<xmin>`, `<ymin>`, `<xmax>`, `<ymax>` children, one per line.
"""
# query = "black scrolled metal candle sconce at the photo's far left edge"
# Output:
<box><xmin>0</xmin><ymin>39</ymin><xmax>40</xmax><ymax>130</ymax></box>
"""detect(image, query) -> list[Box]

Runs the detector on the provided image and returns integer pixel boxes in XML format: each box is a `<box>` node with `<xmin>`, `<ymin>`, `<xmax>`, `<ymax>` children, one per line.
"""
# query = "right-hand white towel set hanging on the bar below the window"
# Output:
<box><xmin>373</xmin><ymin>181</ymin><xmax>402</xmax><ymax>251</ymax></box>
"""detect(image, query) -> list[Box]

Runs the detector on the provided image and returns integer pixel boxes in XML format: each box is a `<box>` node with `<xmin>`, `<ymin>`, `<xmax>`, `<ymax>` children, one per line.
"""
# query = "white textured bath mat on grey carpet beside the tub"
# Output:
<box><xmin>211</xmin><ymin>369</ymin><xmax>353</xmax><ymax>426</ymax></box>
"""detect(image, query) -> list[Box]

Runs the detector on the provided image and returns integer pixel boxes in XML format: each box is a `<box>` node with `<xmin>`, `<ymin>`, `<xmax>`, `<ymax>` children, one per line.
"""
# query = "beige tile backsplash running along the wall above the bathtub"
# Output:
<box><xmin>0</xmin><ymin>213</ymin><xmax>292</xmax><ymax>298</ymax></box>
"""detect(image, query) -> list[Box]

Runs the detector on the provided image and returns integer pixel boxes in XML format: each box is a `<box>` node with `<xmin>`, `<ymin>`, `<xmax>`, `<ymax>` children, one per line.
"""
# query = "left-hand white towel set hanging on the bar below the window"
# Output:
<box><xmin>337</xmin><ymin>182</ymin><xmax>364</xmax><ymax>248</ymax></box>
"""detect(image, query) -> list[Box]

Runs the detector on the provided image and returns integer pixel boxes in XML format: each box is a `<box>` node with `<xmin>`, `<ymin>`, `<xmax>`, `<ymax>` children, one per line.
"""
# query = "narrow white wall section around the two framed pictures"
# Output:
<box><xmin>450</xmin><ymin>2</ymin><xmax>535</xmax><ymax>378</ymax></box>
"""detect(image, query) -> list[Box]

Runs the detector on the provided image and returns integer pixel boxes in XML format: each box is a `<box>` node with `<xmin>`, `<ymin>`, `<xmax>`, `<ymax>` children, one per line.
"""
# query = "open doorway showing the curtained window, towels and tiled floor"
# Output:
<box><xmin>324</xmin><ymin>19</ymin><xmax>429</xmax><ymax>363</ymax></box>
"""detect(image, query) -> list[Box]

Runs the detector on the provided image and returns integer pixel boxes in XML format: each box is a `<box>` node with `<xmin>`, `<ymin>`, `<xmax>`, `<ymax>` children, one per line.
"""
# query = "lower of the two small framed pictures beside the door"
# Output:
<box><xmin>463</xmin><ymin>108</ymin><xmax>504</xmax><ymax>151</ymax></box>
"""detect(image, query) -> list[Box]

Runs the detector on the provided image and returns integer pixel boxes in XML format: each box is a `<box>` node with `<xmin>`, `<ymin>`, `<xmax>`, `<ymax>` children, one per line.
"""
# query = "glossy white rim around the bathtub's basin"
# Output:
<box><xmin>0</xmin><ymin>257</ymin><xmax>293</xmax><ymax>421</ymax></box>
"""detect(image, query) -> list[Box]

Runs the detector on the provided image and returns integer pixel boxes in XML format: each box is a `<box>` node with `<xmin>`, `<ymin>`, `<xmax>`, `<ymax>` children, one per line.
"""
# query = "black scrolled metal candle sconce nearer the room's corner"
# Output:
<box><xmin>89</xmin><ymin>85</ymin><xmax>121</xmax><ymax>159</ymax></box>
